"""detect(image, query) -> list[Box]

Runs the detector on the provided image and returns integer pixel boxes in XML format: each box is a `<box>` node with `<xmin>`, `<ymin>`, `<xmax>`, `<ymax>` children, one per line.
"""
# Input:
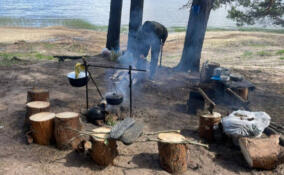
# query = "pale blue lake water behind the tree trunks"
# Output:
<box><xmin>0</xmin><ymin>0</ymin><xmax>268</xmax><ymax>28</ymax></box>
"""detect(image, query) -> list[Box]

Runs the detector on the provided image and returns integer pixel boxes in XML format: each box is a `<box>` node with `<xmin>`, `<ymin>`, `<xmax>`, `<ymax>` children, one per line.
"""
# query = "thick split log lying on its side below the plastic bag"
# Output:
<box><xmin>239</xmin><ymin>135</ymin><xmax>280</xmax><ymax>170</ymax></box>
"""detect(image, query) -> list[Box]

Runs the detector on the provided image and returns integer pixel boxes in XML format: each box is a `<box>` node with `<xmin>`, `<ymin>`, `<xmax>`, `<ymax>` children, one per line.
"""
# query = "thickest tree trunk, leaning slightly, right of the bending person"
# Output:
<box><xmin>177</xmin><ymin>0</ymin><xmax>214</xmax><ymax>72</ymax></box>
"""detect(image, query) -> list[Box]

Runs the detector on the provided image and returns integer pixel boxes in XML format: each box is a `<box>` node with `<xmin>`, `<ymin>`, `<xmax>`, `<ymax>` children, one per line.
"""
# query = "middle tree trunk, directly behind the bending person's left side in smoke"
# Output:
<box><xmin>127</xmin><ymin>0</ymin><xmax>144</xmax><ymax>53</ymax></box>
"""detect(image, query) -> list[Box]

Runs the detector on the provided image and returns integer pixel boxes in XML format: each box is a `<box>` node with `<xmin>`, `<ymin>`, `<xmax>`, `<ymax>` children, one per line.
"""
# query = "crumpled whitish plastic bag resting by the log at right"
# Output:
<box><xmin>221</xmin><ymin>110</ymin><xmax>271</xmax><ymax>137</ymax></box>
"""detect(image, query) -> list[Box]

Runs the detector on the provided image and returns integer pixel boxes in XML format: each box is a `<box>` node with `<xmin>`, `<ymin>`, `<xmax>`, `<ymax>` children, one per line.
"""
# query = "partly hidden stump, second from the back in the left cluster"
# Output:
<box><xmin>25</xmin><ymin>101</ymin><xmax>50</xmax><ymax>124</ymax></box>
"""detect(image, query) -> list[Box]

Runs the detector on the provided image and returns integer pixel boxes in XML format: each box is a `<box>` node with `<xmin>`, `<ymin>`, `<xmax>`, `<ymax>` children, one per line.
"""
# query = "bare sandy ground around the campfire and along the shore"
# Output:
<box><xmin>0</xmin><ymin>27</ymin><xmax>284</xmax><ymax>175</ymax></box>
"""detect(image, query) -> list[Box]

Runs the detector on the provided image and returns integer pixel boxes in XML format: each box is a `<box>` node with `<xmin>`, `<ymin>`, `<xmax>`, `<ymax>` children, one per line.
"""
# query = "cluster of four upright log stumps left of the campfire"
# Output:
<box><xmin>25</xmin><ymin>88</ymin><xmax>81</xmax><ymax>149</ymax></box>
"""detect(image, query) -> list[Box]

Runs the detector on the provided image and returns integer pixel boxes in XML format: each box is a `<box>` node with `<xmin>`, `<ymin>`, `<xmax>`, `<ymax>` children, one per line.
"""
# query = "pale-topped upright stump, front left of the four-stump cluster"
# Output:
<box><xmin>30</xmin><ymin>112</ymin><xmax>55</xmax><ymax>145</ymax></box>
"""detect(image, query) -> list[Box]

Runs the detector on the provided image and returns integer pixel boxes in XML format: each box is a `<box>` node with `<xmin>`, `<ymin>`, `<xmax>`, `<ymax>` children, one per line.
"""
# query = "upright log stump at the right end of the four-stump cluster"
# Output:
<box><xmin>54</xmin><ymin>112</ymin><xmax>82</xmax><ymax>149</ymax></box>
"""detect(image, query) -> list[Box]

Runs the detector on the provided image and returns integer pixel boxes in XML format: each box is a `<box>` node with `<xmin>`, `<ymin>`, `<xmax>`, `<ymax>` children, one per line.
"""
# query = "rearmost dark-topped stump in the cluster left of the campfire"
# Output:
<box><xmin>27</xmin><ymin>88</ymin><xmax>49</xmax><ymax>103</ymax></box>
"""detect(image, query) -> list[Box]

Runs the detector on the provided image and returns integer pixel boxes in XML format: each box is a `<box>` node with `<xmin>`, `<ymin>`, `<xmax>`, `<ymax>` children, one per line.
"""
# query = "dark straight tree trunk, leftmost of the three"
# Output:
<box><xmin>106</xmin><ymin>0</ymin><xmax>123</xmax><ymax>51</ymax></box>
